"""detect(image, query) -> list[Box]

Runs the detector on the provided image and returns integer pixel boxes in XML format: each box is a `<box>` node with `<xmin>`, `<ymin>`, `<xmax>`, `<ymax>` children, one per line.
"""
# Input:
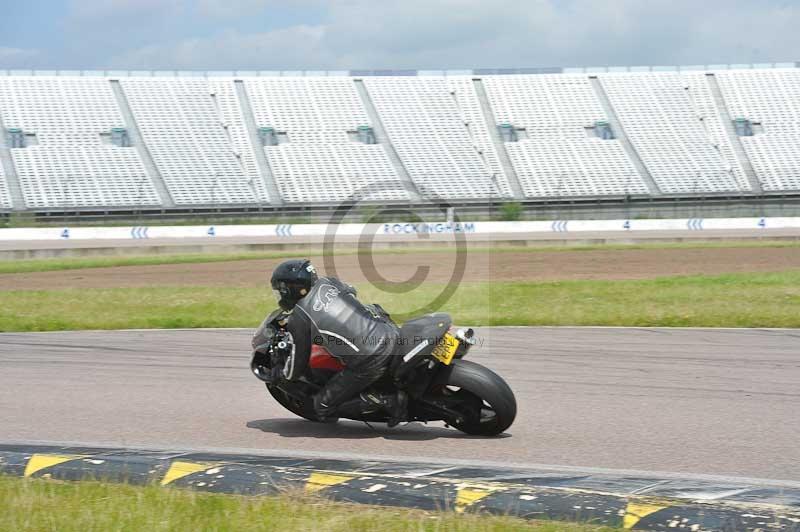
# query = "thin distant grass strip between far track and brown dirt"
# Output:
<box><xmin>0</xmin><ymin>240</ymin><xmax>800</xmax><ymax>274</ymax></box>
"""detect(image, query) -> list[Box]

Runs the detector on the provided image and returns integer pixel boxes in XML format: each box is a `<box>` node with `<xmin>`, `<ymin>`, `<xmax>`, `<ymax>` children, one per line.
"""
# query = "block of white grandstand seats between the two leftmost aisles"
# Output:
<box><xmin>0</xmin><ymin>76</ymin><xmax>160</xmax><ymax>209</ymax></box>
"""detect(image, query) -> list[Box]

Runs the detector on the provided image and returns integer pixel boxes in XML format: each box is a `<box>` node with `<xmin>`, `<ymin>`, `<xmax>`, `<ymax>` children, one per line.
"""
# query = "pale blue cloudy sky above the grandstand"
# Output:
<box><xmin>0</xmin><ymin>0</ymin><xmax>800</xmax><ymax>70</ymax></box>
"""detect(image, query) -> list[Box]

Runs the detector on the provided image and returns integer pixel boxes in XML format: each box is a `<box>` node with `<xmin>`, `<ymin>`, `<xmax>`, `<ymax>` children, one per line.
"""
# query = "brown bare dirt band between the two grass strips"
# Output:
<box><xmin>0</xmin><ymin>247</ymin><xmax>800</xmax><ymax>290</ymax></box>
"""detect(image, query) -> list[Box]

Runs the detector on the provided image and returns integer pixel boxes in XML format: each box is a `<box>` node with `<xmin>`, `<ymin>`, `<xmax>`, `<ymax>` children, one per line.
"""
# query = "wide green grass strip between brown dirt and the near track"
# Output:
<box><xmin>0</xmin><ymin>270</ymin><xmax>800</xmax><ymax>331</ymax></box>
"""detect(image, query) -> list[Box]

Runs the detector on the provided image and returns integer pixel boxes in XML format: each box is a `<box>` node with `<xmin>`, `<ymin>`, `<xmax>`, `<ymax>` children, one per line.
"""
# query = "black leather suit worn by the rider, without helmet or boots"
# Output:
<box><xmin>286</xmin><ymin>277</ymin><xmax>399</xmax><ymax>418</ymax></box>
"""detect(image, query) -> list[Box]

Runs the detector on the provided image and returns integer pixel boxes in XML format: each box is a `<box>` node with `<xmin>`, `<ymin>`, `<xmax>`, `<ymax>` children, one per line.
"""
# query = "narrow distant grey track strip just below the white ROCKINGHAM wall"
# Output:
<box><xmin>0</xmin><ymin>228</ymin><xmax>800</xmax><ymax>258</ymax></box>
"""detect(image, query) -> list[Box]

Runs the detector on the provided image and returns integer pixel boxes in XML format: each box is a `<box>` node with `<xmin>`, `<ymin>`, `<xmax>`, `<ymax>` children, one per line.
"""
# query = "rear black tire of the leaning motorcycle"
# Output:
<box><xmin>440</xmin><ymin>360</ymin><xmax>517</xmax><ymax>436</ymax></box>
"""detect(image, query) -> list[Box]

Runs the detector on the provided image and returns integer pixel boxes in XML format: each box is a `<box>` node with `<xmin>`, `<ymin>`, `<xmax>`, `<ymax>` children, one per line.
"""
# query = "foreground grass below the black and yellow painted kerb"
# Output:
<box><xmin>0</xmin><ymin>476</ymin><xmax>610</xmax><ymax>532</ymax></box>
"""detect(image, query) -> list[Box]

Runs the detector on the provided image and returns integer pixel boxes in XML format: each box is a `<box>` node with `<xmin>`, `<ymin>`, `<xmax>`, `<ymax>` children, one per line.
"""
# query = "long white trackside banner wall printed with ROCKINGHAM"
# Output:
<box><xmin>0</xmin><ymin>217</ymin><xmax>800</xmax><ymax>241</ymax></box>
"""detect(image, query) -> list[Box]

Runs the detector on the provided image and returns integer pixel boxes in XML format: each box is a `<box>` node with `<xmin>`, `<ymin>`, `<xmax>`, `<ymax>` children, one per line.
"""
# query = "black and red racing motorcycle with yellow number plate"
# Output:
<box><xmin>250</xmin><ymin>310</ymin><xmax>517</xmax><ymax>436</ymax></box>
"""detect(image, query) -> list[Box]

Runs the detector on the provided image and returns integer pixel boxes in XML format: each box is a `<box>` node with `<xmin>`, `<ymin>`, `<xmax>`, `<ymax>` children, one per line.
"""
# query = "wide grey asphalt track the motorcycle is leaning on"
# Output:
<box><xmin>0</xmin><ymin>327</ymin><xmax>800</xmax><ymax>481</ymax></box>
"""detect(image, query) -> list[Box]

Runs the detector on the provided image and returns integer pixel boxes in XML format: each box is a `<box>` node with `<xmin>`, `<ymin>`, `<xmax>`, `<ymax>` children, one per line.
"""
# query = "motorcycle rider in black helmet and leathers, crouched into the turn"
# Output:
<box><xmin>271</xmin><ymin>259</ymin><xmax>407</xmax><ymax>427</ymax></box>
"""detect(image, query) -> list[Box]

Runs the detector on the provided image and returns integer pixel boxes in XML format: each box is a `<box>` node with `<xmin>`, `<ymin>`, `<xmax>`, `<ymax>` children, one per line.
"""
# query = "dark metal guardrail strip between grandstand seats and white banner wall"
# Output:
<box><xmin>0</xmin><ymin>192</ymin><xmax>800</xmax><ymax>225</ymax></box>
